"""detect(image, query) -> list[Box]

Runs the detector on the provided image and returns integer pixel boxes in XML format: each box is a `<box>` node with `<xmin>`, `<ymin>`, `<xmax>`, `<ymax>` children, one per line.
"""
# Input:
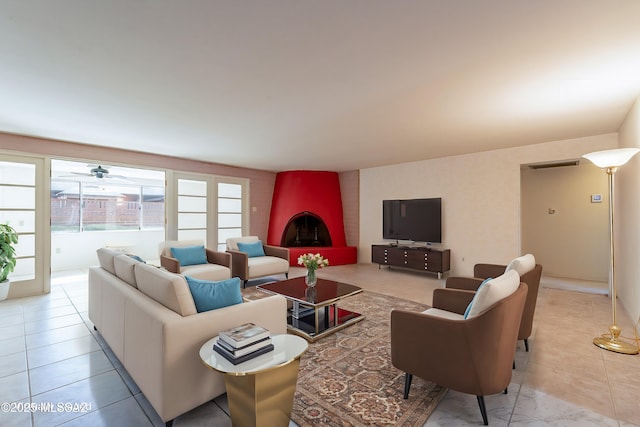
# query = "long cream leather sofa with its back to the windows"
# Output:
<box><xmin>89</xmin><ymin>248</ymin><xmax>287</xmax><ymax>425</ymax></box>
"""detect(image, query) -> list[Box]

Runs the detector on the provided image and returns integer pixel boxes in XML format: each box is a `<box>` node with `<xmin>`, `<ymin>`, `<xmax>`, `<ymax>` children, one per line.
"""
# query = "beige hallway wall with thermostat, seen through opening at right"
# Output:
<box><xmin>521</xmin><ymin>159</ymin><xmax>609</xmax><ymax>282</ymax></box>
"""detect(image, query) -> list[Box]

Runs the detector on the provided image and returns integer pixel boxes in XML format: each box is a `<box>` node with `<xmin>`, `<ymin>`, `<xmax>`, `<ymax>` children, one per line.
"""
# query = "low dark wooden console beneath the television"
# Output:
<box><xmin>371</xmin><ymin>245</ymin><xmax>451</xmax><ymax>279</ymax></box>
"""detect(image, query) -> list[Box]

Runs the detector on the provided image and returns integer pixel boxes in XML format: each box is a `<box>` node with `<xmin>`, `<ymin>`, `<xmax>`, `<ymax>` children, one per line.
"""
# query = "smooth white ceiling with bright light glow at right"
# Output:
<box><xmin>0</xmin><ymin>0</ymin><xmax>640</xmax><ymax>171</ymax></box>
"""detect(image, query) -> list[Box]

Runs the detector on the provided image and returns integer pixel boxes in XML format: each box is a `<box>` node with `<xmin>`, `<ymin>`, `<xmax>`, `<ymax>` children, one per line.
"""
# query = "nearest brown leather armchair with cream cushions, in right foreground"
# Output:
<box><xmin>391</xmin><ymin>272</ymin><xmax>527</xmax><ymax>425</ymax></box>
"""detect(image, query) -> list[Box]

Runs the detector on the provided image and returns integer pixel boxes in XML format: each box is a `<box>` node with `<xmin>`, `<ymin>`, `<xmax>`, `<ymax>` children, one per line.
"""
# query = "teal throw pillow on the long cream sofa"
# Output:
<box><xmin>185</xmin><ymin>276</ymin><xmax>242</xmax><ymax>313</ymax></box>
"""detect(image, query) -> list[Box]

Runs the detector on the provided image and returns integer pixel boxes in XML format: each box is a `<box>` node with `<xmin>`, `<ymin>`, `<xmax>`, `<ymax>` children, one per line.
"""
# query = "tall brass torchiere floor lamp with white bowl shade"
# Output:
<box><xmin>582</xmin><ymin>148</ymin><xmax>640</xmax><ymax>354</ymax></box>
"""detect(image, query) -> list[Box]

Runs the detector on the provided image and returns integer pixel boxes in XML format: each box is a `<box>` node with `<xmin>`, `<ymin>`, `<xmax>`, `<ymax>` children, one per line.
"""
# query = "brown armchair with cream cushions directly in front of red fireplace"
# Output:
<box><xmin>227</xmin><ymin>236</ymin><xmax>289</xmax><ymax>287</ymax></box>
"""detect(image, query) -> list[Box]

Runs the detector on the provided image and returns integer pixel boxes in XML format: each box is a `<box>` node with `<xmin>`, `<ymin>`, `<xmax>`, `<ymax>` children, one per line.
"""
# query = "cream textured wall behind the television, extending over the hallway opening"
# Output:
<box><xmin>358</xmin><ymin>134</ymin><xmax>618</xmax><ymax>275</ymax></box>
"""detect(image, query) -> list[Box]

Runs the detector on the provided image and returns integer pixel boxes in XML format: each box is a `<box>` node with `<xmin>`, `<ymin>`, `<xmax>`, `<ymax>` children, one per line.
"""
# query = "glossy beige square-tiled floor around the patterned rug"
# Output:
<box><xmin>0</xmin><ymin>265</ymin><xmax>640</xmax><ymax>427</ymax></box>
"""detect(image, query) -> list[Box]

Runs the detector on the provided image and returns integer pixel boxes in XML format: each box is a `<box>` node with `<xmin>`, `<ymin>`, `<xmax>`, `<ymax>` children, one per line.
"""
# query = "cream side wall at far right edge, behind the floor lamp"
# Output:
<box><xmin>615</xmin><ymin>98</ymin><xmax>640</xmax><ymax>333</ymax></box>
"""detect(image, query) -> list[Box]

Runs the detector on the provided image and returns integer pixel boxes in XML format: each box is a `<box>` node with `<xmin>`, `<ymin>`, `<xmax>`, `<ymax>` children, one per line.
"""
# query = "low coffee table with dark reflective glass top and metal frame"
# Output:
<box><xmin>256</xmin><ymin>277</ymin><xmax>364</xmax><ymax>342</ymax></box>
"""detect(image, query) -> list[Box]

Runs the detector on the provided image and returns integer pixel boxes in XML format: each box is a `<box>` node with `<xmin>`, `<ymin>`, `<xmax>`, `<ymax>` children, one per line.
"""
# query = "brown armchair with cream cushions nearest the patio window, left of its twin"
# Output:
<box><xmin>159</xmin><ymin>240</ymin><xmax>232</xmax><ymax>281</ymax></box>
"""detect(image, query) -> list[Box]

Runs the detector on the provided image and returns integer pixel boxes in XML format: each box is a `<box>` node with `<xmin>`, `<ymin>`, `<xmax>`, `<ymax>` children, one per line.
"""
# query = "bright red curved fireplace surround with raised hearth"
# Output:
<box><xmin>267</xmin><ymin>171</ymin><xmax>357</xmax><ymax>265</ymax></box>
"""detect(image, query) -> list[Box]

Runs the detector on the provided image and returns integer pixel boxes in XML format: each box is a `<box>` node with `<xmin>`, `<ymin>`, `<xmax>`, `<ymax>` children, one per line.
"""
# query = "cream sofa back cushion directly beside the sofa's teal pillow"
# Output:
<box><xmin>134</xmin><ymin>263</ymin><xmax>197</xmax><ymax>316</ymax></box>
